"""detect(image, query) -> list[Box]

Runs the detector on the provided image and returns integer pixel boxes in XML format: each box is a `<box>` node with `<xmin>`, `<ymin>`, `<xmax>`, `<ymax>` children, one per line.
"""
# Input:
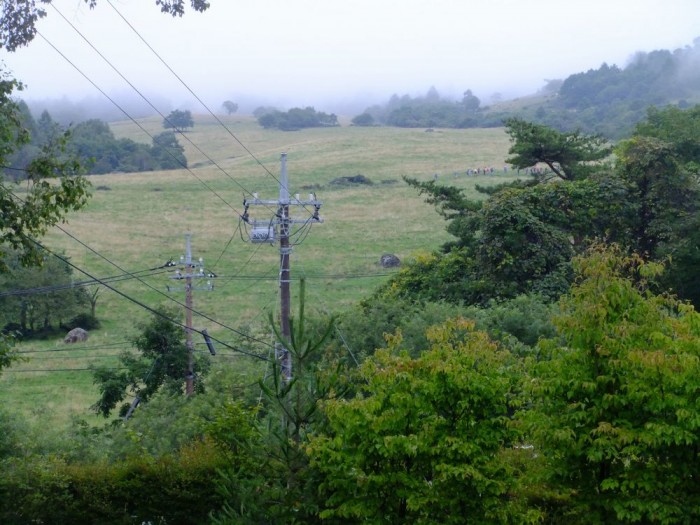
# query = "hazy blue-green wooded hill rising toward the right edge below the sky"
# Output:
<box><xmin>353</xmin><ymin>38</ymin><xmax>700</xmax><ymax>139</ymax></box>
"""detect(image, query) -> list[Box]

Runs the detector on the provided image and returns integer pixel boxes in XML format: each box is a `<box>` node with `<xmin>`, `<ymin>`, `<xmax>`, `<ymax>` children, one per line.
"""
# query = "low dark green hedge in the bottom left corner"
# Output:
<box><xmin>0</xmin><ymin>442</ymin><xmax>225</xmax><ymax>525</ymax></box>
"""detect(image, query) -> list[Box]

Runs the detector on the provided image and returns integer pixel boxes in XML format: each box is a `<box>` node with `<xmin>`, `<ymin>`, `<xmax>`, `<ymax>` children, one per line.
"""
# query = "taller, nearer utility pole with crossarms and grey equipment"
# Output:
<box><xmin>243</xmin><ymin>153</ymin><xmax>323</xmax><ymax>383</ymax></box>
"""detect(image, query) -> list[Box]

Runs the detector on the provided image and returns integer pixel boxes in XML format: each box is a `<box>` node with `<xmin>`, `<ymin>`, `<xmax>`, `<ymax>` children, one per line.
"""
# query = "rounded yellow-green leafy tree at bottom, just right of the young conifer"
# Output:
<box><xmin>308</xmin><ymin>319</ymin><xmax>528</xmax><ymax>524</ymax></box>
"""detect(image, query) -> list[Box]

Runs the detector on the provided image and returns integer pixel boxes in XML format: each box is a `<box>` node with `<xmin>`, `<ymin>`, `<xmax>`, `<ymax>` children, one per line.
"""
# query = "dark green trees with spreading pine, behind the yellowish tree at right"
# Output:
<box><xmin>386</xmin><ymin>108</ymin><xmax>700</xmax><ymax>304</ymax></box>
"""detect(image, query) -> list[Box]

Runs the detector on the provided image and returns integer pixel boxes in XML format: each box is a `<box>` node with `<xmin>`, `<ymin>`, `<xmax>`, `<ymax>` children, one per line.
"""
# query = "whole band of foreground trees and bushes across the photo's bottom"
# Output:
<box><xmin>0</xmin><ymin>245</ymin><xmax>700</xmax><ymax>524</ymax></box>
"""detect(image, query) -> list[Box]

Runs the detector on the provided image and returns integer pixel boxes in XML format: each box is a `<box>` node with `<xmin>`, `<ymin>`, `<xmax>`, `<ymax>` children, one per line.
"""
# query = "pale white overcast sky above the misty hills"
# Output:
<box><xmin>2</xmin><ymin>0</ymin><xmax>700</xmax><ymax>111</ymax></box>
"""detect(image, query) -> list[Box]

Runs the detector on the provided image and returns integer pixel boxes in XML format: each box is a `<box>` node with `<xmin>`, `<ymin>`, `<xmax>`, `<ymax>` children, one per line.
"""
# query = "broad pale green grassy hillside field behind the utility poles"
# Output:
<box><xmin>0</xmin><ymin>115</ymin><xmax>510</xmax><ymax>425</ymax></box>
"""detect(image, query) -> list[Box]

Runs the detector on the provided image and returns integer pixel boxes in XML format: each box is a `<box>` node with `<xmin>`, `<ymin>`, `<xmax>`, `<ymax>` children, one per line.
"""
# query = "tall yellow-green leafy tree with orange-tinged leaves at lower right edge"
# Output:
<box><xmin>524</xmin><ymin>246</ymin><xmax>700</xmax><ymax>523</ymax></box>
